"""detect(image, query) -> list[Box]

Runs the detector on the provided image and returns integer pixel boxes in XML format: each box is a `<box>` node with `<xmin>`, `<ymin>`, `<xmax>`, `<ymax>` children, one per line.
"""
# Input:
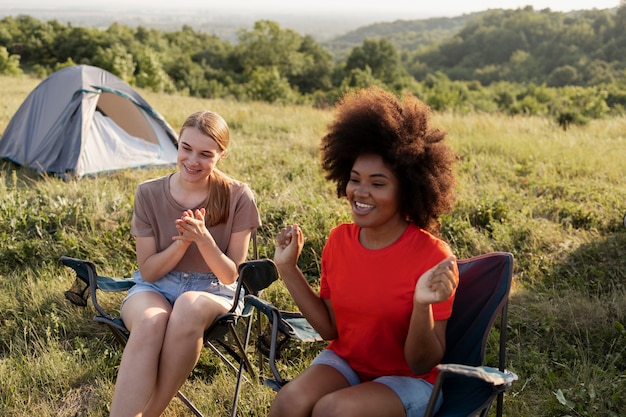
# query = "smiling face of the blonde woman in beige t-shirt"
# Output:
<box><xmin>178</xmin><ymin>127</ymin><xmax>225</xmax><ymax>182</ymax></box>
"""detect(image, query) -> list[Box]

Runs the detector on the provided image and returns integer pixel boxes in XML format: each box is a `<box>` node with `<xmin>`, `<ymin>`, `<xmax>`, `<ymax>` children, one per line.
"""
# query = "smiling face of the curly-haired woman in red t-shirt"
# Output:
<box><xmin>346</xmin><ymin>155</ymin><xmax>406</xmax><ymax>234</ymax></box>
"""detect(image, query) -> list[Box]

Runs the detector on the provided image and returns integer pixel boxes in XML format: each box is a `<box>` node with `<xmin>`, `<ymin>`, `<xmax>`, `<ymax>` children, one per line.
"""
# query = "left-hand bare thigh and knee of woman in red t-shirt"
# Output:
<box><xmin>269</xmin><ymin>365</ymin><xmax>349</xmax><ymax>417</ymax></box>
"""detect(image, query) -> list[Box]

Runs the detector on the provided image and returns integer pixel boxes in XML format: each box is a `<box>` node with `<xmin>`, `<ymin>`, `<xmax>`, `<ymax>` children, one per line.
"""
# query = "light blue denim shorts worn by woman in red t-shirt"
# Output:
<box><xmin>311</xmin><ymin>349</ymin><xmax>443</xmax><ymax>417</ymax></box>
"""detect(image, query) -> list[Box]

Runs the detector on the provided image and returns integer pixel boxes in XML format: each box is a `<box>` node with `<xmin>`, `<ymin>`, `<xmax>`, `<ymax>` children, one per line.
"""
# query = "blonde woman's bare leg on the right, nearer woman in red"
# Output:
<box><xmin>144</xmin><ymin>291</ymin><xmax>231</xmax><ymax>416</ymax></box>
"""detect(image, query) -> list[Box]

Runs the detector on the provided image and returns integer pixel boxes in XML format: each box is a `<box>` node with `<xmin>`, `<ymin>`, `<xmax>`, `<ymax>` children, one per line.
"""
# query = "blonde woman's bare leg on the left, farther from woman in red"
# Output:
<box><xmin>111</xmin><ymin>291</ymin><xmax>171</xmax><ymax>417</ymax></box>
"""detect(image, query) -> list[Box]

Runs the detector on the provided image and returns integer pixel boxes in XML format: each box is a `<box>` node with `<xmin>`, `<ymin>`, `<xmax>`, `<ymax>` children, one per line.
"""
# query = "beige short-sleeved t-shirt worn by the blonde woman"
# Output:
<box><xmin>130</xmin><ymin>174</ymin><xmax>261</xmax><ymax>272</ymax></box>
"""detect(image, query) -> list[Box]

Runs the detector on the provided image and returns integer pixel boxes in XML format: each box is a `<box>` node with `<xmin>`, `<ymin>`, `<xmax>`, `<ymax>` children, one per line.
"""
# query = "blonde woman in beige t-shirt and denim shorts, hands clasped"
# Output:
<box><xmin>111</xmin><ymin>111</ymin><xmax>260</xmax><ymax>416</ymax></box>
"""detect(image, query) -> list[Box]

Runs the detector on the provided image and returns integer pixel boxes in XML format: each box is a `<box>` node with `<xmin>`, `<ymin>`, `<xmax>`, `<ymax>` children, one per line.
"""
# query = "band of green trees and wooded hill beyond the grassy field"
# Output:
<box><xmin>0</xmin><ymin>5</ymin><xmax>626</xmax><ymax>128</ymax></box>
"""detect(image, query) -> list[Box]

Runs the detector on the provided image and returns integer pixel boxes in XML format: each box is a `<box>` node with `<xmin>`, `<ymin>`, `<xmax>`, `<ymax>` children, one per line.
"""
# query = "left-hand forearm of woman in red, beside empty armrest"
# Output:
<box><xmin>276</xmin><ymin>264</ymin><xmax>337</xmax><ymax>340</ymax></box>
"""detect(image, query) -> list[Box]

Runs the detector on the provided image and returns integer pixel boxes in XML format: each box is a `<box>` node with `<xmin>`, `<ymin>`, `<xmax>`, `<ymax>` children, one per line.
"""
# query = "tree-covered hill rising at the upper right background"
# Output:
<box><xmin>407</xmin><ymin>7</ymin><xmax>626</xmax><ymax>86</ymax></box>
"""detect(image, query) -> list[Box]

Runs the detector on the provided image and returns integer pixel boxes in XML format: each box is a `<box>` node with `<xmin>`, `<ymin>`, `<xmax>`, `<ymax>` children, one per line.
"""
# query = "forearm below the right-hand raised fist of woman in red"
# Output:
<box><xmin>404</xmin><ymin>303</ymin><xmax>445</xmax><ymax>375</ymax></box>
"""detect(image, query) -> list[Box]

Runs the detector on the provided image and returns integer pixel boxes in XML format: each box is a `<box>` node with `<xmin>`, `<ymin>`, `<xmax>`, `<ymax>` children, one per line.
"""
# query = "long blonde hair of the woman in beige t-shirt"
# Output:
<box><xmin>180</xmin><ymin>110</ymin><xmax>232</xmax><ymax>226</ymax></box>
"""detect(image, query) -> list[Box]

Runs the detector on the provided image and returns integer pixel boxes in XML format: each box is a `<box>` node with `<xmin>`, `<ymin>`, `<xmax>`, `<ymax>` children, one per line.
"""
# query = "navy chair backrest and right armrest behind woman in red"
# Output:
<box><xmin>425</xmin><ymin>252</ymin><xmax>517</xmax><ymax>417</ymax></box>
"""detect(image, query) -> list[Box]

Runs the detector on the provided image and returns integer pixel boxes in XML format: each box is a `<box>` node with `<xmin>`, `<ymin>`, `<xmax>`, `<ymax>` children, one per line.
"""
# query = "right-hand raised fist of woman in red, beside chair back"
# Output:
<box><xmin>413</xmin><ymin>256</ymin><xmax>458</xmax><ymax>304</ymax></box>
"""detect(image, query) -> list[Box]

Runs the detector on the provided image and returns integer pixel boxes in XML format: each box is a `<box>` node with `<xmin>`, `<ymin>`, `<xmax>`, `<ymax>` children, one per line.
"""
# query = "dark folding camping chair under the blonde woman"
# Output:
<box><xmin>59</xmin><ymin>236</ymin><xmax>278</xmax><ymax>417</ymax></box>
